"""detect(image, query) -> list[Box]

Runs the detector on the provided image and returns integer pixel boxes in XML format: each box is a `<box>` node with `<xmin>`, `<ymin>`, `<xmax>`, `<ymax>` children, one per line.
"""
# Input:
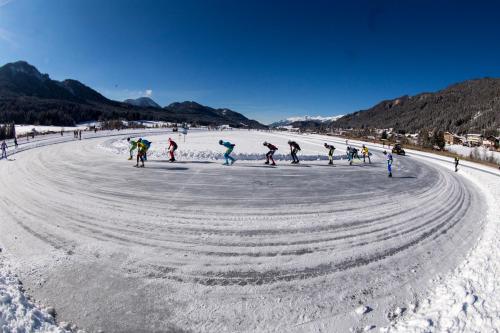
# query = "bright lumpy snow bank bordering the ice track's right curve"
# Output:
<box><xmin>381</xmin><ymin>152</ymin><xmax>500</xmax><ymax>333</ymax></box>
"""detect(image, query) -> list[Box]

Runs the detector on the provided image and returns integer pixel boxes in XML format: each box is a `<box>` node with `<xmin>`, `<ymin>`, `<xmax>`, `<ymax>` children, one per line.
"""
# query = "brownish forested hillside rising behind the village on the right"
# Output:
<box><xmin>331</xmin><ymin>77</ymin><xmax>500</xmax><ymax>135</ymax></box>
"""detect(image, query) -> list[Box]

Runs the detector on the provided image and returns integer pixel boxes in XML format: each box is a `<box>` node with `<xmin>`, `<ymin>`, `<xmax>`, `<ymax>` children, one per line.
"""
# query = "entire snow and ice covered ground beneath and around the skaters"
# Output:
<box><xmin>0</xmin><ymin>131</ymin><xmax>500</xmax><ymax>332</ymax></box>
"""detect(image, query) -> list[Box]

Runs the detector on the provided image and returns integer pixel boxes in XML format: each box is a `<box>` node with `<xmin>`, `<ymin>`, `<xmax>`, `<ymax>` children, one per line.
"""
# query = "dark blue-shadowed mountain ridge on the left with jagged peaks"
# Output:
<box><xmin>0</xmin><ymin>61</ymin><xmax>267</xmax><ymax>128</ymax></box>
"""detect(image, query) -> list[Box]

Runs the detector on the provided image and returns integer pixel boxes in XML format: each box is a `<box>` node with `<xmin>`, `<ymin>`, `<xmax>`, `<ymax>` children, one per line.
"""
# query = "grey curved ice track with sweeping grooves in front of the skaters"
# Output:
<box><xmin>0</xmin><ymin>134</ymin><xmax>483</xmax><ymax>331</ymax></box>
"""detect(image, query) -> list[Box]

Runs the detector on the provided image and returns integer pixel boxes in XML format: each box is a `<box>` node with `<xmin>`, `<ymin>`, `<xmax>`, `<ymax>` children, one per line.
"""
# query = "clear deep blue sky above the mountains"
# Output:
<box><xmin>0</xmin><ymin>0</ymin><xmax>500</xmax><ymax>123</ymax></box>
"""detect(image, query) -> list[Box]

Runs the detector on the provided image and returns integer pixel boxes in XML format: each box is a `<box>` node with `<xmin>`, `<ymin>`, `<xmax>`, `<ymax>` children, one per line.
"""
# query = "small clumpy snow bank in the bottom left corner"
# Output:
<box><xmin>0</xmin><ymin>259</ymin><xmax>70</xmax><ymax>333</ymax></box>
